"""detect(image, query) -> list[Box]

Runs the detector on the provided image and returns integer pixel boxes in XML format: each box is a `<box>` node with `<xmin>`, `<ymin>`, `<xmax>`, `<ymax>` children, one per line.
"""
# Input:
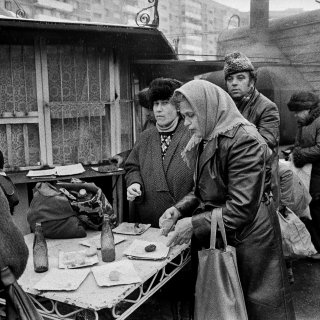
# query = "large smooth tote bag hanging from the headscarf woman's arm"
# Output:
<box><xmin>194</xmin><ymin>208</ymin><xmax>248</xmax><ymax>320</ymax></box>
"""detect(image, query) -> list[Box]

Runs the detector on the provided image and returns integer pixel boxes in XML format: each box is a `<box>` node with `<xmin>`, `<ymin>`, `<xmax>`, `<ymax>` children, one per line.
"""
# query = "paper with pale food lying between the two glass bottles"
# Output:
<box><xmin>59</xmin><ymin>247</ymin><xmax>99</xmax><ymax>269</ymax></box>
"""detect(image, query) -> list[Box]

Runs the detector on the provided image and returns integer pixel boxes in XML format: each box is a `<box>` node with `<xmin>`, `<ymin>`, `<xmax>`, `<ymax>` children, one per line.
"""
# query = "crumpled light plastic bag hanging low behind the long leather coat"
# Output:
<box><xmin>277</xmin><ymin>207</ymin><xmax>317</xmax><ymax>259</ymax></box>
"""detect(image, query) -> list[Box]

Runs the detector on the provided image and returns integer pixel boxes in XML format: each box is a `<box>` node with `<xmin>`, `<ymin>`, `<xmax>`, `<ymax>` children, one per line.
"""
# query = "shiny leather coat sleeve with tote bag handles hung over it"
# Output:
<box><xmin>192</xmin><ymin>135</ymin><xmax>267</xmax><ymax>240</ymax></box>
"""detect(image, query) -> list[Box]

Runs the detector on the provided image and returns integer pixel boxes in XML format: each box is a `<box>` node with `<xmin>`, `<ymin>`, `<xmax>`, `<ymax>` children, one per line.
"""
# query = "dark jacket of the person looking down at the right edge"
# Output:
<box><xmin>293</xmin><ymin>107</ymin><xmax>320</xmax><ymax>200</ymax></box>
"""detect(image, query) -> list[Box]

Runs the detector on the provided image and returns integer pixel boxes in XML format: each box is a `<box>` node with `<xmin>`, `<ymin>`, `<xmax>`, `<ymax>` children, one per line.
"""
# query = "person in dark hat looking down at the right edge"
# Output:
<box><xmin>288</xmin><ymin>91</ymin><xmax>320</xmax><ymax>254</ymax></box>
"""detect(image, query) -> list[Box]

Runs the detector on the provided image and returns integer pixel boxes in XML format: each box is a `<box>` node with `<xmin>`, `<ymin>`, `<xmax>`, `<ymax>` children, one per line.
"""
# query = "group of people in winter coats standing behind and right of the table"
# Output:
<box><xmin>125</xmin><ymin>52</ymin><xmax>320</xmax><ymax>320</ymax></box>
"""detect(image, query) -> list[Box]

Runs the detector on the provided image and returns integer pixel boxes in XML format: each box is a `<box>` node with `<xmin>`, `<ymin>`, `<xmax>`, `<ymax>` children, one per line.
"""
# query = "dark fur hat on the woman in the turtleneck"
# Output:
<box><xmin>149</xmin><ymin>78</ymin><xmax>182</xmax><ymax>105</ymax></box>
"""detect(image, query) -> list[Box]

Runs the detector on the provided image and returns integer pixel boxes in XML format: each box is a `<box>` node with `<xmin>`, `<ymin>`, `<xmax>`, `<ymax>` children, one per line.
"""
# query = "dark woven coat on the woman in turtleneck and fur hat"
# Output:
<box><xmin>125</xmin><ymin>121</ymin><xmax>193</xmax><ymax>227</ymax></box>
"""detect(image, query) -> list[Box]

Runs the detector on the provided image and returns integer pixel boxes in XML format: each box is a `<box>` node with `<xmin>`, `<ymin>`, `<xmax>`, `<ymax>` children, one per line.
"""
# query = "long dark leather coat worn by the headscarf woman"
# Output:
<box><xmin>175</xmin><ymin>125</ymin><xmax>295</xmax><ymax>320</ymax></box>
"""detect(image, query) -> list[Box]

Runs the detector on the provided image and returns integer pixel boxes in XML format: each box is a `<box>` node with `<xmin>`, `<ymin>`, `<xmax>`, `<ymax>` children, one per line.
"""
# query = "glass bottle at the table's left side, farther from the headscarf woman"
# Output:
<box><xmin>33</xmin><ymin>222</ymin><xmax>49</xmax><ymax>272</ymax></box>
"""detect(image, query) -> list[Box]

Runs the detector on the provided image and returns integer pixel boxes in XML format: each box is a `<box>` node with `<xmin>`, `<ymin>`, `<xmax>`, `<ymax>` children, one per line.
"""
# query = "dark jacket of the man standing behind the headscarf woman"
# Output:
<box><xmin>239</xmin><ymin>90</ymin><xmax>280</xmax><ymax>205</ymax></box>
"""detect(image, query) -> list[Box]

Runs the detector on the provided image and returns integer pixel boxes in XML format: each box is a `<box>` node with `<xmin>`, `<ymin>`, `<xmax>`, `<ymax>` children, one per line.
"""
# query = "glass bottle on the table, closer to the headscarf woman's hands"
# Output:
<box><xmin>101</xmin><ymin>214</ymin><xmax>116</xmax><ymax>262</ymax></box>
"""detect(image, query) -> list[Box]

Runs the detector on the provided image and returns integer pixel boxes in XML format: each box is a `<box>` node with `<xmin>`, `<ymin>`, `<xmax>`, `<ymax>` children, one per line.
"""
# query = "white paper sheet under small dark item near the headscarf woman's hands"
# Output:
<box><xmin>123</xmin><ymin>240</ymin><xmax>170</xmax><ymax>260</ymax></box>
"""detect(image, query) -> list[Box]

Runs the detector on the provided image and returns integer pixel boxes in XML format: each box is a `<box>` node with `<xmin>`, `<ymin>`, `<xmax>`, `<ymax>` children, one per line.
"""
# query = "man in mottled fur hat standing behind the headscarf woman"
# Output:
<box><xmin>223</xmin><ymin>52</ymin><xmax>280</xmax><ymax>206</ymax></box>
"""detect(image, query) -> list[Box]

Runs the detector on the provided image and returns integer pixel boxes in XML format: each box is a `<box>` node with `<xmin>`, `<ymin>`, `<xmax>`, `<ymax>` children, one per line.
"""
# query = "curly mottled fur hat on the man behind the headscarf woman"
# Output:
<box><xmin>223</xmin><ymin>51</ymin><xmax>254</xmax><ymax>79</ymax></box>
